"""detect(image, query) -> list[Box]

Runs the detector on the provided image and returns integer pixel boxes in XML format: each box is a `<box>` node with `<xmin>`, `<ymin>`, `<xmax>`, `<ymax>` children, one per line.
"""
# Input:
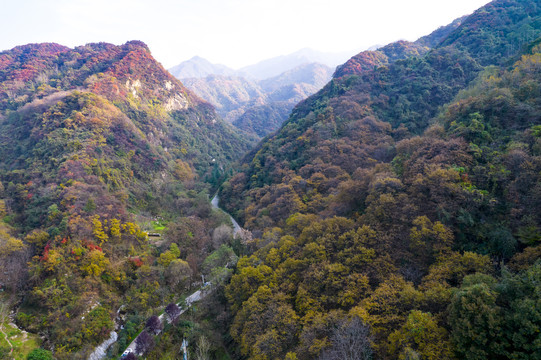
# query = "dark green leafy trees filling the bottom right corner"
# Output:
<box><xmin>449</xmin><ymin>263</ymin><xmax>541</xmax><ymax>359</ymax></box>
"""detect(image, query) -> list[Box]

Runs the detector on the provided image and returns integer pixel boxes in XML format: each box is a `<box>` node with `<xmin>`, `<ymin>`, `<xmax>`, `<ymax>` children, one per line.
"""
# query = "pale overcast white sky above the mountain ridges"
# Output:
<box><xmin>0</xmin><ymin>0</ymin><xmax>489</xmax><ymax>68</ymax></box>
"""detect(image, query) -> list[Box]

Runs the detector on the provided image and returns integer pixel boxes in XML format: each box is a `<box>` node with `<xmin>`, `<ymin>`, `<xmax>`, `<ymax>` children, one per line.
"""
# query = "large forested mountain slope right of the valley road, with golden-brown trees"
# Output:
<box><xmin>221</xmin><ymin>0</ymin><xmax>541</xmax><ymax>359</ymax></box>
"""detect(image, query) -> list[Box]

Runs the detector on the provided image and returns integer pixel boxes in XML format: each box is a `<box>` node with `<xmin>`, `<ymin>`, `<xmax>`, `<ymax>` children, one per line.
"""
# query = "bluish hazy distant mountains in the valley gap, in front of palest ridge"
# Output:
<box><xmin>182</xmin><ymin>63</ymin><xmax>332</xmax><ymax>137</ymax></box>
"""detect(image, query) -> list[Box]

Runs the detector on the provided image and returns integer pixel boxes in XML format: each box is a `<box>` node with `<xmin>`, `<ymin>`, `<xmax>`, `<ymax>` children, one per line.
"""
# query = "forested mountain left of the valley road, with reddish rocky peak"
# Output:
<box><xmin>0</xmin><ymin>41</ymin><xmax>255</xmax><ymax>359</ymax></box>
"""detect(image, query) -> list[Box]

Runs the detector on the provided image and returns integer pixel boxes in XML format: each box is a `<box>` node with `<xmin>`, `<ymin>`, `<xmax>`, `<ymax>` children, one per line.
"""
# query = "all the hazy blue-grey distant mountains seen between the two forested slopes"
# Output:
<box><xmin>169</xmin><ymin>49</ymin><xmax>349</xmax><ymax>137</ymax></box>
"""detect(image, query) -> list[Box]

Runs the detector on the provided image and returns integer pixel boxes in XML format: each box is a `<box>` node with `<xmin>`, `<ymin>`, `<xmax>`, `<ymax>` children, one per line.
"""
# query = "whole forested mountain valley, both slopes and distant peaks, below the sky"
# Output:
<box><xmin>0</xmin><ymin>0</ymin><xmax>541</xmax><ymax>360</ymax></box>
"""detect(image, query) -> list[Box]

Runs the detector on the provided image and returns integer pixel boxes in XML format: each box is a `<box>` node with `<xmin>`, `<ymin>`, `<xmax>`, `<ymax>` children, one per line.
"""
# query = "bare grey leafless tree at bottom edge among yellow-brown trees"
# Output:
<box><xmin>319</xmin><ymin>316</ymin><xmax>373</xmax><ymax>360</ymax></box>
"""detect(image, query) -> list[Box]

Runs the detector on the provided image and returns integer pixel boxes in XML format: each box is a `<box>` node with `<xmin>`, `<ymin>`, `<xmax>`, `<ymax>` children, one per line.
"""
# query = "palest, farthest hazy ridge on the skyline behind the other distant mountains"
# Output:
<box><xmin>238</xmin><ymin>49</ymin><xmax>351</xmax><ymax>80</ymax></box>
